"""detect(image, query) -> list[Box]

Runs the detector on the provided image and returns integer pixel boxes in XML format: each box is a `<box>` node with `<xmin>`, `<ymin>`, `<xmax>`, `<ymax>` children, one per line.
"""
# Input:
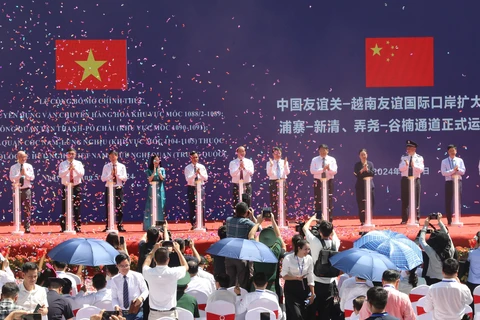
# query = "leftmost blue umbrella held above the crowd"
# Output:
<box><xmin>48</xmin><ymin>238</ymin><xmax>118</xmax><ymax>266</ymax></box>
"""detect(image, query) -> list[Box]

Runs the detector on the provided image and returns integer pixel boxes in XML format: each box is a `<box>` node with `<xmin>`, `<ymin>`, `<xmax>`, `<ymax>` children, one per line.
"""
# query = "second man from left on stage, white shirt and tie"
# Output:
<box><xmin>58</xmin><ymin>148</ymin><xmax>85</xmax><ymax>232</ymax></box>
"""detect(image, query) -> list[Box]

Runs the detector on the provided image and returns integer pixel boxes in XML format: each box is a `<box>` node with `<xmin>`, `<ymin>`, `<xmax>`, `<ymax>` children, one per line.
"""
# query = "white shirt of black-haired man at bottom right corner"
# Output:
<box><xmin>423</xmin><ymin>279</ymin><xmax>473</xmax><ymax>320</ymax></box>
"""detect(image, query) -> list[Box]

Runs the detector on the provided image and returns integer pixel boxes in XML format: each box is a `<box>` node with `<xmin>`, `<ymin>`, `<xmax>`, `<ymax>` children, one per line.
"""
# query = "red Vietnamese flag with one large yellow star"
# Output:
<box><xmin>55</xmin><ymin>40</ymin><xmax>127</xmax><ymax>90</ymax></box>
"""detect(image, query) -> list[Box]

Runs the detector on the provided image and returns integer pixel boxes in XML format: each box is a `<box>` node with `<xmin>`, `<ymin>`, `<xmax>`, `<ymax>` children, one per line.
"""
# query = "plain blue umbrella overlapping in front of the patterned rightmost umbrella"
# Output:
<box><xmin>330</xmin><ymin>248</ymin><xmax>397</xmax><ymax>281</ymax></box>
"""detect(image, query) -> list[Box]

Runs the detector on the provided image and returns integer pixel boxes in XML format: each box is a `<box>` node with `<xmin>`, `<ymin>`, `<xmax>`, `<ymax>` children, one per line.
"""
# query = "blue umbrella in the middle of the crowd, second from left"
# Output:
<box><xmin>207</xmin><ymin>238</ymin><xmax>278</xmax><ymax>263</ymax></box>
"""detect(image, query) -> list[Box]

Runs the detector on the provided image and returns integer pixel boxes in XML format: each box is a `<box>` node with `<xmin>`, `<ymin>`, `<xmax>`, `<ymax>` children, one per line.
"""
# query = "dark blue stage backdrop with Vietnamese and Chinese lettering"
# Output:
<box><xmin>0</xmin><ymin>0</ymin><xmax>480</xmax><ymax>222</ymax></box>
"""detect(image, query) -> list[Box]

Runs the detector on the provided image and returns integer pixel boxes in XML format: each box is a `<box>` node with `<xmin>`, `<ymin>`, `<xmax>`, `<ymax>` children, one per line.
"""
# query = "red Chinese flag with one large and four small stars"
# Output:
<box><xmin>365</xmin><ymin>37</ymin><xmax>433</xmax><ymax>88</ymax></box>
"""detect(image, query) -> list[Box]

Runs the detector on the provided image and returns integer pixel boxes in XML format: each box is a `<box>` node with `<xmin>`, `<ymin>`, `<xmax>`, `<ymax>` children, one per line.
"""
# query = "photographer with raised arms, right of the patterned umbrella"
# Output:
<box><xmin>419</xmin><ymin>213</ymin><xmax>455</xmax><ymax>286</ymax></box>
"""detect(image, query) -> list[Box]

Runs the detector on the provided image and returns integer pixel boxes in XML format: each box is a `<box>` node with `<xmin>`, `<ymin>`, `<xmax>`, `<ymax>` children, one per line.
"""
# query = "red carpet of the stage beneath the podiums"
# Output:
<box><xmin>0</xmin><ymin>215</ymin><xmax>480</xmax><ymax>258</ymax></box>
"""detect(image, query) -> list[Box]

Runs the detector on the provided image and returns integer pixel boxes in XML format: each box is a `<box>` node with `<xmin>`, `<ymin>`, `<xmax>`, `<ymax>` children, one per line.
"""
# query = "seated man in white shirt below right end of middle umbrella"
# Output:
<box><xmin>236</xmin><ymin>272</ymin><xmax>282</xmax><ymax>320</ymax></box>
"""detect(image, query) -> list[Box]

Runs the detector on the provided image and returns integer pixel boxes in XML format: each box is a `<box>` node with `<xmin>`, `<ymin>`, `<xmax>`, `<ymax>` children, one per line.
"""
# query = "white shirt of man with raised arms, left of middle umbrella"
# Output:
<box><xmin>143</xmin><ymin>266</ymin><xmax>187</xmax><ymax>311</ymax></box>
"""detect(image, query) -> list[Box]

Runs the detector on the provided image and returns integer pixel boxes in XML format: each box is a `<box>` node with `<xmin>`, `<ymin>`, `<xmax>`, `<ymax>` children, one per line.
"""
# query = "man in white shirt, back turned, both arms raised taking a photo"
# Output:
<box><xmin>143</xmin><ymin>241</ymin><xmax>188</xmax><ymax>320</ymax></box>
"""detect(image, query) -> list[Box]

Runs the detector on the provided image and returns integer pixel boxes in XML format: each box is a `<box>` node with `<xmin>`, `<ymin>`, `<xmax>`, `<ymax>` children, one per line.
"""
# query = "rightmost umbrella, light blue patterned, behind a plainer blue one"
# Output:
<box><xmin>353</xmin><ymin>230</ymin><xmax>423</xmax><ymax>270</ymax></box>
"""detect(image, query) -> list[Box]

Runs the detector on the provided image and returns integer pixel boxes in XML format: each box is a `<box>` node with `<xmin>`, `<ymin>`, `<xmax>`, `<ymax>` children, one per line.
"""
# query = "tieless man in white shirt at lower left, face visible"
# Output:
<box><xmin>17</xmin><ymin>262</ymin><xmax>48</xmax><ymax>319</ymax></box>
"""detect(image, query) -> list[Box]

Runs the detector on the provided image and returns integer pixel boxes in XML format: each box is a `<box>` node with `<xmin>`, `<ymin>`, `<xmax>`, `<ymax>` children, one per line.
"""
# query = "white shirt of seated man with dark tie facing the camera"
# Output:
<box><xmin>111</xmin><ymin>270</ymin><xmax>148</xmax><ymax>310</ymax></box>
